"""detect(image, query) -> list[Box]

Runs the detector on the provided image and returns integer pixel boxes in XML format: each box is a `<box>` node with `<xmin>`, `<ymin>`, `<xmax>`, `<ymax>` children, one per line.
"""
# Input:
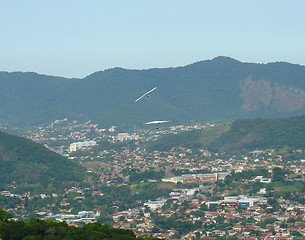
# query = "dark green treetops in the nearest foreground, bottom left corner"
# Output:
<box><xmin>0</xmin><ymin>210</ymin><xmax>157</xmax><ymax>240</ymax></box>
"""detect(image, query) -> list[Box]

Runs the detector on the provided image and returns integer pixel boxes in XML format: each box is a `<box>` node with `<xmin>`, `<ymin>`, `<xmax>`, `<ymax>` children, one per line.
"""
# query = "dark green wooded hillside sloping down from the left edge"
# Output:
<box><xmin>0</xmin><ymin>132</ymin><xmax>86</xmax><ymax>191</ymax></box>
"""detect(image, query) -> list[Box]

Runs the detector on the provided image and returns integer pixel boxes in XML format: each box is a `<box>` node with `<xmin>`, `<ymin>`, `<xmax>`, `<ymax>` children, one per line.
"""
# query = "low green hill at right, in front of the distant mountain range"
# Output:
<box><xmin>147</xmin><ymin>115</ymin><xmax>305</xmax><ymax>153</ymax></box>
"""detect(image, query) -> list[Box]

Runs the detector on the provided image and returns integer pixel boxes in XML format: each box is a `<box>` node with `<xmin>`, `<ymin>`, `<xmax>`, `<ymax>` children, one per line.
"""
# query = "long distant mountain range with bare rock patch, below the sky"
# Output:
<box><xmin>0</xmin><ymin>57</ymin><xmax>305</xmax><ymax>128</ymax></box>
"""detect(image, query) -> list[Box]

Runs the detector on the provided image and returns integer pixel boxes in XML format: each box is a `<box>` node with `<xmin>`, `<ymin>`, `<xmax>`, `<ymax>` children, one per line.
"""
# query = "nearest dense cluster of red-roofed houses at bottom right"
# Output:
<box><xmin>112</xmin><ymin>188</ymin><xmax>305</xmax><ymax>240</ymax></box>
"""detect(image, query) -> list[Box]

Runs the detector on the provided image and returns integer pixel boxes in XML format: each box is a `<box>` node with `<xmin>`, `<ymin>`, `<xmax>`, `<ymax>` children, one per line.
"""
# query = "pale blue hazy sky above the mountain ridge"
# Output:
<box><xmin>0</xmin><ymin>0</ymin><xmax>305</xmax><ymax>77</ymax></box>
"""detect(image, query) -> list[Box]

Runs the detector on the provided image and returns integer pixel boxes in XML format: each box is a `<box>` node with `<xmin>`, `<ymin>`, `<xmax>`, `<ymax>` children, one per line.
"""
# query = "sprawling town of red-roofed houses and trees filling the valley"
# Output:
<box><xmin>0</xmin><ymin>119</ymin><xmax>305</xmax><ymax>239</ymax></box>
